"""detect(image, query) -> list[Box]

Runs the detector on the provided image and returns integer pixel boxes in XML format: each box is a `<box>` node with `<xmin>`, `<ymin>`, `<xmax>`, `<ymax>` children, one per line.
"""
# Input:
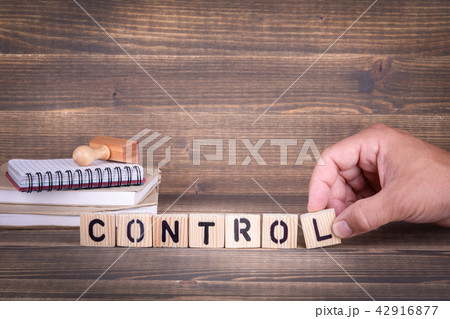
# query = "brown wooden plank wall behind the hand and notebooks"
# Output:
<box><xmin>0</xmin><ymin>0</ymin><xmax>450</xmax><ymax>196</ymax></box>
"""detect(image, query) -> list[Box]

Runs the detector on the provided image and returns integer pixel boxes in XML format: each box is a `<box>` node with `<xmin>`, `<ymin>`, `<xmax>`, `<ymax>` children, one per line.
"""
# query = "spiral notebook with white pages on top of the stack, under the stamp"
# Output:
<box><xmin>7</xmin><ymin>158</ymin><xmax>145</xmax><ymax>193</ymax></box>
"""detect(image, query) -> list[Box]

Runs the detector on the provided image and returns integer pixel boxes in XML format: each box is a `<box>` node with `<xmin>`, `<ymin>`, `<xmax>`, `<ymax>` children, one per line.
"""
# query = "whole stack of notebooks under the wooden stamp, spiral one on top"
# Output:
<box><xmin>0</xmin><ymin>159</ymin><xmax>161</xmax><ymax>226</ymax></box>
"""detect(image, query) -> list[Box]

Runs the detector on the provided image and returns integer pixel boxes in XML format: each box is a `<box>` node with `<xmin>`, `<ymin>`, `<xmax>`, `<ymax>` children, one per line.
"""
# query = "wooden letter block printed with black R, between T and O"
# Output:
<box><xmin>225</xmin><ymin>214</ymin><xmax>261</xmax><ymax>248</ymax></box>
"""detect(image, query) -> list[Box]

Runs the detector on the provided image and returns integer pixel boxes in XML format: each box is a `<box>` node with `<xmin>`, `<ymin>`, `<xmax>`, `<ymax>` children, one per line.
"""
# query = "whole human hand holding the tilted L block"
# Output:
<box><xmin>308</xmin><ymin>124</ymin><xmax>450</xmax><ymax>238</ymax></box>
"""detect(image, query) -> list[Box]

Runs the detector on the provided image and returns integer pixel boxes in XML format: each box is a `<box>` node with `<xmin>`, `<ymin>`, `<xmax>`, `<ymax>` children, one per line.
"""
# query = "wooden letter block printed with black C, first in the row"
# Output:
<box><xmin>80</xmin><ymin>213</ymin><xmax>116</xmax><ymax>247</ymax></box>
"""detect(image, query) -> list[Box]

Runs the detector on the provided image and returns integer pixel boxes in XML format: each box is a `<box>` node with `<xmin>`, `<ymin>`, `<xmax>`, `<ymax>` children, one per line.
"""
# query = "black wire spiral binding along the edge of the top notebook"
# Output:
<box><xmin>25</xmin><ymin>165</ymin><xmax>143</xmax><ymax>193</ymax></box>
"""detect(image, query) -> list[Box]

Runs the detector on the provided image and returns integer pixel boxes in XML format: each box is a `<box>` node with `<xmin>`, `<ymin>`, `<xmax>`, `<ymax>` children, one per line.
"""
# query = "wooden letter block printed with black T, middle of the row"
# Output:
<box><xmin>189</xmin><ymin>214</ymin><xmax>225</xmax><ymax>248</ymax></box>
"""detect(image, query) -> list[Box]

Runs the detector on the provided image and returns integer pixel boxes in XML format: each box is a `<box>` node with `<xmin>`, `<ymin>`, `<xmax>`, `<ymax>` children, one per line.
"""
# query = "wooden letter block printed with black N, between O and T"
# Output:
<box><xmin>153</xmin><ymin>214</ymin><xmax>189</xmax><ymax>247</ymax></box>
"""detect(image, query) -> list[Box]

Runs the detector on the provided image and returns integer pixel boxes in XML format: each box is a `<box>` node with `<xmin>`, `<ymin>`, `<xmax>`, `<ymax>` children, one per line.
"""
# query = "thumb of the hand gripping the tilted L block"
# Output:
<box><xmin>333</xmin><ymin>189</ymin><xmax>396</xmax><ymax>238</ymax></box>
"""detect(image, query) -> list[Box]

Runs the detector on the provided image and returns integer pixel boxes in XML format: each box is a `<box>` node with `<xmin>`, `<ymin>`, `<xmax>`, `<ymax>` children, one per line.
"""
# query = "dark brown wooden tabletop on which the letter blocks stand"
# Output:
<box><xmin>0</xmin><ymin>195</ymin><xmax>450</xmax><ymax>300</ymax></box>
